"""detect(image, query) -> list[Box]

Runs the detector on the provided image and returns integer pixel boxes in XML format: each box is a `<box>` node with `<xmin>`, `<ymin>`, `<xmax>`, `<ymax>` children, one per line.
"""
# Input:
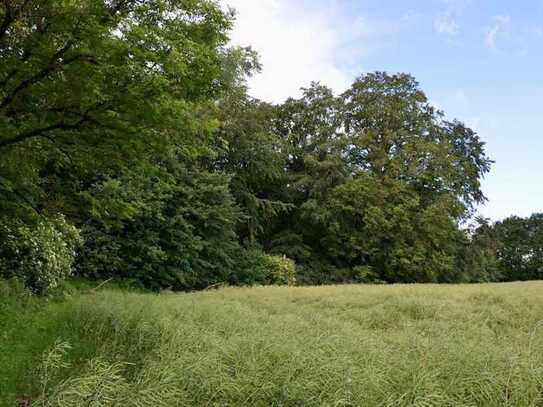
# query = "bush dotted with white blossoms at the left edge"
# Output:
<box><xmin>0</xmin><ymin>215</ymin><xmax>82</xmax><ymax>294</ymax></box>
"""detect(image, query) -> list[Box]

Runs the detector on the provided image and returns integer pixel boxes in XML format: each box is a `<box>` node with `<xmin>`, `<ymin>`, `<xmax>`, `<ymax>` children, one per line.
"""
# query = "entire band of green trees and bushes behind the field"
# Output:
<box><xmin>0</xmin><ymin>0</ymin><xmax>543</xmax><ymax>292</ymax></box>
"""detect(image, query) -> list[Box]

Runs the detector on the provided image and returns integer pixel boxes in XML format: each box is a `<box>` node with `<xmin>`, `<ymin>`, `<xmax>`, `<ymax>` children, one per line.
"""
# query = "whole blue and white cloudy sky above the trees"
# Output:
<box><xmin>220</xmin><ymin>0</ymin><xmax>543</xmax><ymax>220</ymax></box>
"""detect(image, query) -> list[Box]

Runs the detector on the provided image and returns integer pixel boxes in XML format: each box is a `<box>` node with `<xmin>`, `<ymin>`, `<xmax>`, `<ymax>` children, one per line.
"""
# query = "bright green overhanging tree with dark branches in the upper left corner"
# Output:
<box><xmin>0</xmin><ymin>0</ymin><xmax>230</xmax><ymax>220</ymax></box>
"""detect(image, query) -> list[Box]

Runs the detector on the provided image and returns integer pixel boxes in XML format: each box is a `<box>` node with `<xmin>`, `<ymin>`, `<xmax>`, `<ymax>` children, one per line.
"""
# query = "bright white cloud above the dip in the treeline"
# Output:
<box><xmin>223</xmin><ymin>0</ymin><xmax>352</xmax><ymax>102</ymax></box>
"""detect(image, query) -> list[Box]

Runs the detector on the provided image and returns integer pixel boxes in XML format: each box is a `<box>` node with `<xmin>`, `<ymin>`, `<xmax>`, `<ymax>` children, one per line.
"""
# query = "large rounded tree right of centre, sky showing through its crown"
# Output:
<box><xmin>271</xmin><ymin>72</ymin><xmax>491</xmax><ymax>282</ymax></box>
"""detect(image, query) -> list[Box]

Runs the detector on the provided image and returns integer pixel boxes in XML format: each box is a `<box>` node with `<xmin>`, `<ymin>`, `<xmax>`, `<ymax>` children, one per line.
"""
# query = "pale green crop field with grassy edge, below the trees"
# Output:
<box><xmin>0</xmin><ymin>282</ymin><xmax>543</xmax><ymax>406</ymax></box>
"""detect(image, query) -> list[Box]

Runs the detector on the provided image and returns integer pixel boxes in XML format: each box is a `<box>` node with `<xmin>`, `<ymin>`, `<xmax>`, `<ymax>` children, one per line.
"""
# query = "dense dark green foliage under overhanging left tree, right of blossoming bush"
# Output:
<box><xmin>79</xmin><ymin>164</ymin><xmax>239</xmax><ymax>290</ymax></box>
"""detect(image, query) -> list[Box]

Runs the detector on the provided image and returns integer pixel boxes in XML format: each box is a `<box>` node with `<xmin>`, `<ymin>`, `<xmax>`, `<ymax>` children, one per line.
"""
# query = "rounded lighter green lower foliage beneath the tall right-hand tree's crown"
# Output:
<box><xmin>323</xmin><ymin>174</ymin><xmax>462</xmax><ymax>282</ymax></box>
